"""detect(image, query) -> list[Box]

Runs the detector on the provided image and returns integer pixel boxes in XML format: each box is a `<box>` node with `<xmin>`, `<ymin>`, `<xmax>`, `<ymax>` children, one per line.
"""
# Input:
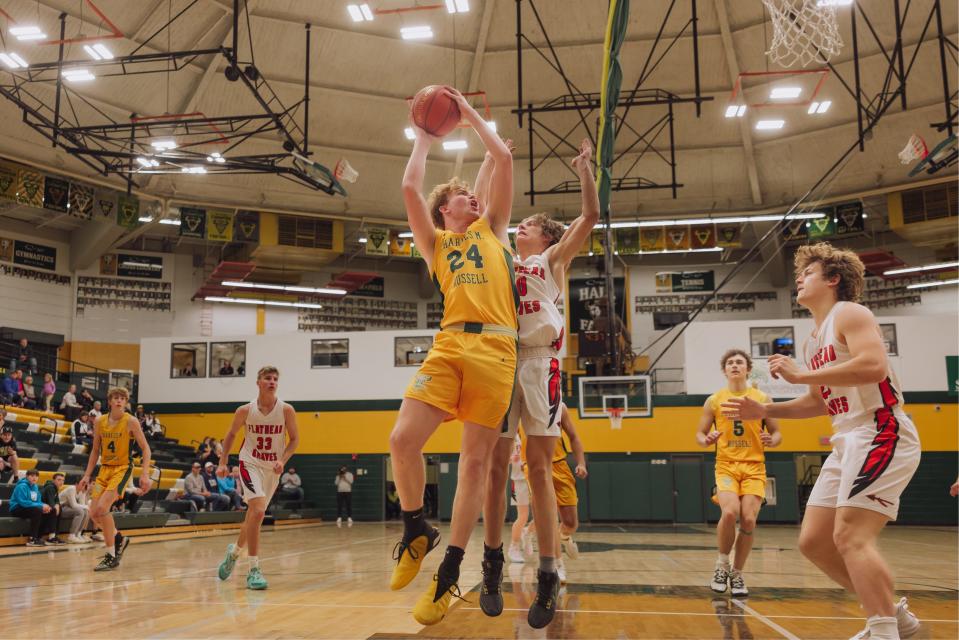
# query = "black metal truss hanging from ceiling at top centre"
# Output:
<box><xmin>512</xmin><ymin>0</ymin><xmax>712</xmax><ymax>205</ymax></box>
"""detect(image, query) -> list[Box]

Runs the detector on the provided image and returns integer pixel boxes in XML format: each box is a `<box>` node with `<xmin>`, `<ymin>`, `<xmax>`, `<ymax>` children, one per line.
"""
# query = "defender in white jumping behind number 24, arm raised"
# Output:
<box><xmin>480</xmin><ymin>140</ymin><xmax>599</xmax><ymax>629</ymax></box>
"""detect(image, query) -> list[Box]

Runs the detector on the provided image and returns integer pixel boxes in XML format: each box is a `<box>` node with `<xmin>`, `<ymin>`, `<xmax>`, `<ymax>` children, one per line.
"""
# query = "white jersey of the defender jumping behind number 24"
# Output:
<box><xmin>513</xmin><ymin>254</ymin><xmax>564</xmax><ymax>351</ymax></box>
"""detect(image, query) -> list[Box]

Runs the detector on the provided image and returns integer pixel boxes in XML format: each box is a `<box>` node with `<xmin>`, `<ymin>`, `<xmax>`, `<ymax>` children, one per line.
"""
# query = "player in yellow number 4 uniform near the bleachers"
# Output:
<box><xmin>77</xmin><ymin>387</ymin><xmax>153</xmax><ymax>571</ymax></box>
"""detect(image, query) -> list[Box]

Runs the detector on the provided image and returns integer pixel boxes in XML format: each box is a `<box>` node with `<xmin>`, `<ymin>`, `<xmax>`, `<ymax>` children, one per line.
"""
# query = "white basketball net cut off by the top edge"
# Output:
<box><xmin>763</xmin><ymin>0</ymin><xmax>842</xmax><ymax>69</ymax></box>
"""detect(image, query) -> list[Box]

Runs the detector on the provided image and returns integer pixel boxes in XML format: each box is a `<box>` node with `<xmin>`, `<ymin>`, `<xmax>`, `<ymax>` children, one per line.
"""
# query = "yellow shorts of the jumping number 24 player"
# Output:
<box><xmin>404</xmin><ymin>331</ymin><xmax>516</xmax><ymax>429</ymax></box>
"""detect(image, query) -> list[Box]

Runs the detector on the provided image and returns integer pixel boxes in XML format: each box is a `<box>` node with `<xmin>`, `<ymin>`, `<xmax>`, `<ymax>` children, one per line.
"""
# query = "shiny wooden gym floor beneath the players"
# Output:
<box><xmin>0</xmin><ymin>523</ymin><xmax>959</xmax><ymax>640</ymax></box>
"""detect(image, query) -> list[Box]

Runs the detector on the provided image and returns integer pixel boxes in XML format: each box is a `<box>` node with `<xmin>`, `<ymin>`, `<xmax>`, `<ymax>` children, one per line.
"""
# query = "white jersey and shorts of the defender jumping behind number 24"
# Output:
<box><xmin>502</xmin><ymin>254</ymin><xmax>565</xmax><ymax>438</ymax></box>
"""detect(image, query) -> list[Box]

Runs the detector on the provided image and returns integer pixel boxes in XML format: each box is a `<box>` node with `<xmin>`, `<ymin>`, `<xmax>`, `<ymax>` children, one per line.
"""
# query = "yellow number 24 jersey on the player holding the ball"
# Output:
<box><xmin>433</xmin><ymin>216</ymin><xmax>519</xmax><ymax>329</ymax></box>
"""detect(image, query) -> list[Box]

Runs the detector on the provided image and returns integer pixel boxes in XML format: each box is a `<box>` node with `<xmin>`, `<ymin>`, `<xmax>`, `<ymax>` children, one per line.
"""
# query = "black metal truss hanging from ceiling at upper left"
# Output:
<box><xmin>0</xmin><ymin>0</ymin><xmax>345</xmax><ymax>195</ymax></box>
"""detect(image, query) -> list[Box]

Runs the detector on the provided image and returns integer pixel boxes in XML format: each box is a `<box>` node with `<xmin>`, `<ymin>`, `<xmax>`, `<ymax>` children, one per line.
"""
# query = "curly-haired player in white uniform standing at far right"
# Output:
<box><xmin>723</xmin><ymin>242</ymin><xmax>921</xmax><ymax>640</ymax></box>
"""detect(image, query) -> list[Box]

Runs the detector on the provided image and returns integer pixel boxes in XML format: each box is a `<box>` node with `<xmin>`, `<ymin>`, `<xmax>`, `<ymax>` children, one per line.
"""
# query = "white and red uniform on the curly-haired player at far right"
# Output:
<box><xmin>803</xmin><ymin>302</ymin><xmax>922</xmax><ymax>520</ymax></box>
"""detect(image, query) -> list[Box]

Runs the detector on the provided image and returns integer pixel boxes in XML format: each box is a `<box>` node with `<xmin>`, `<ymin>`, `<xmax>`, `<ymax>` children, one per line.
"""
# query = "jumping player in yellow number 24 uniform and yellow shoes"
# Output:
<box><xmin>390</xmin><ymin>88</ymin><xmax>517</xmax><ymax>624</ymax></box>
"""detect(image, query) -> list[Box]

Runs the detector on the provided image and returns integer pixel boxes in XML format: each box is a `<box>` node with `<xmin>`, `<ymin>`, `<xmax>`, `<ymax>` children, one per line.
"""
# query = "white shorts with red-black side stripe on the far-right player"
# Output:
<box><xmin>806</xmin><ymin>411</ymin><xmax>922</xmax><ymax>520</ymax></box>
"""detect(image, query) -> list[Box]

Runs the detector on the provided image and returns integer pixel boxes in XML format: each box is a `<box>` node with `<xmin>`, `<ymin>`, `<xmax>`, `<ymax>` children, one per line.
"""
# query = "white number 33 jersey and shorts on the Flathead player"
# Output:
<box><xmin>240</xmin><ymin>398</ymin><xmax>287</xmax><ymax>502</ymax></box>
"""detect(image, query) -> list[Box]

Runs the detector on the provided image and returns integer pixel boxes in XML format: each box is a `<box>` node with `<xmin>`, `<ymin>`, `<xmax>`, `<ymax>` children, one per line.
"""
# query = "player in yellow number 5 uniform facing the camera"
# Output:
<box><xmin>696</xmin><ymin>349</ymin><xmax>782</xmax><ymax>597</ymax></box>
